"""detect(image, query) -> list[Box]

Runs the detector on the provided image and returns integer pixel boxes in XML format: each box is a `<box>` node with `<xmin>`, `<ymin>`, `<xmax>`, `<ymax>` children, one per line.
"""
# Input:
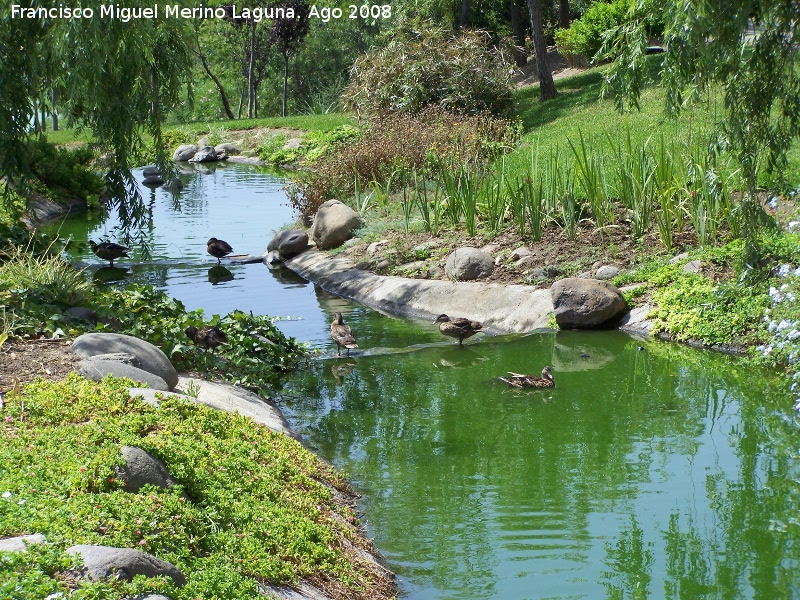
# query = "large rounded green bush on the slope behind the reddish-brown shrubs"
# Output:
<box><xmin>342</xmin><ymin>29</ymin><xmax>514</xmax><ymax>115</ymax></box>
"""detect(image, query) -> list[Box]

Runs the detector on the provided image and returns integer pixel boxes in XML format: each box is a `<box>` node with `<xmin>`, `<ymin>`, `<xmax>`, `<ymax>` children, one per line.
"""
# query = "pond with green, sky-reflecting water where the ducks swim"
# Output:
<box><xmin>50</xmin><ymin>166</ymin><xmax>800</xmax><ymax>600</ymax></box>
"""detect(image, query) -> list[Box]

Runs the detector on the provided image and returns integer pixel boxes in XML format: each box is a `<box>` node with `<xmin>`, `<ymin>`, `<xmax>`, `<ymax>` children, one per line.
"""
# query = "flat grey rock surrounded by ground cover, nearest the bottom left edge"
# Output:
<box><xmin>67</xmin><ymin>544</ymin><xmax>186</xmax><ymax>586</ymax></box>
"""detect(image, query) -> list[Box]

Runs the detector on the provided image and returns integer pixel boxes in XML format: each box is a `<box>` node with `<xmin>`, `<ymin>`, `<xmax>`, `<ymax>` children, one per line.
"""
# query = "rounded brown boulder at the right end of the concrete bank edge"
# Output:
<box><xmin>550</xmin><ymin>277</ymin><xmax>626</xmax><ymax>329</ymax></box>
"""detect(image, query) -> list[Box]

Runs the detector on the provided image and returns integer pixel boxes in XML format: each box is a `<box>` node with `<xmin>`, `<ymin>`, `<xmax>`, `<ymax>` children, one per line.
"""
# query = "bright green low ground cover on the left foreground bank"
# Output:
<box><xmin>0</xmin><ymin>375</ymin><xmax>392</xmax><ymax>600</ymax></box>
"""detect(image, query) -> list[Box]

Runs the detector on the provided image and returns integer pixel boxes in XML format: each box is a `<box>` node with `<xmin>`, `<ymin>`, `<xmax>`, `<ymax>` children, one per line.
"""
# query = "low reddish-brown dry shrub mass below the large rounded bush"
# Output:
<box><xmin>291</xmin><ymin>106</ymin><xmax>519</xmax><ymax>215</ymax></box>
